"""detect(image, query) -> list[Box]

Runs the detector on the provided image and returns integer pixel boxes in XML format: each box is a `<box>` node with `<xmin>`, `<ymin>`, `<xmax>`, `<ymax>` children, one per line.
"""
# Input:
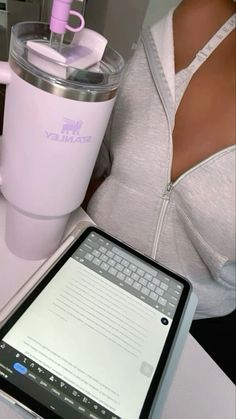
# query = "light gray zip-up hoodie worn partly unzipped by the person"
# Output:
<box><xmin>88</xmin><ymin>12</ymin><xmax>235</xmax><ymax>318</ymax></box>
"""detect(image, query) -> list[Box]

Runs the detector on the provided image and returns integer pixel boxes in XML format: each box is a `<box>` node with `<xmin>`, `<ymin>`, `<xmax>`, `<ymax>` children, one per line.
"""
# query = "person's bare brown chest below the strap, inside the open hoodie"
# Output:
<box><xmin>171</xmin><ymin>30</ymin><xmax>235</xmax><ymax>181</ymax></box>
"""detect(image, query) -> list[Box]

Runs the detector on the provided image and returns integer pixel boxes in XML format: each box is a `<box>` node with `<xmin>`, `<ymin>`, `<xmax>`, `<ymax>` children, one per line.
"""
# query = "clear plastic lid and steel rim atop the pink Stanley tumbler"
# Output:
<box><xmin>9</xmin><ymin>22</ymin><xmax>125</xmax><ymax>102</ymax></box>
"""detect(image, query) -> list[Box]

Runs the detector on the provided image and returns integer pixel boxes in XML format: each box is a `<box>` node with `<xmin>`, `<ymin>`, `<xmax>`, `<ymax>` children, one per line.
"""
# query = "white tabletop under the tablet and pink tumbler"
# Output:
<box><xmin>0</xmin><ymin>194</ymin><xmax>236</xmax><ymax>419</ymax></box>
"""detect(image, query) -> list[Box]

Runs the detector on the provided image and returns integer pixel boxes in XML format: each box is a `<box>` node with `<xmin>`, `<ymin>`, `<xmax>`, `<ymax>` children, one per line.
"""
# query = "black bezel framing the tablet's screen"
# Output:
<box><xmin>0</xmin><ymin>226</ymin><xmax>192</xmax><ymax>419</ymax></box>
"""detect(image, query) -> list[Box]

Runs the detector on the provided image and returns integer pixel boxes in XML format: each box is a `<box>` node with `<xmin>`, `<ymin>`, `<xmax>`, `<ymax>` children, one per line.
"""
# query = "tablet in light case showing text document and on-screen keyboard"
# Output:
<box><xmin>0</xmin><ymin>226</ymin><xmax>196</xmax><ymax>419</ymax></box>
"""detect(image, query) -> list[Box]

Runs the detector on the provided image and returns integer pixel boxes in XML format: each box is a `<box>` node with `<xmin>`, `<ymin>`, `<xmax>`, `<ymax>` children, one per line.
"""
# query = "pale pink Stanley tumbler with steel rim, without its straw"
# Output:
<box><xmin>0</xmin><ymin>22</ymin><xmax>124</xmax><ymax>259</ymax></box>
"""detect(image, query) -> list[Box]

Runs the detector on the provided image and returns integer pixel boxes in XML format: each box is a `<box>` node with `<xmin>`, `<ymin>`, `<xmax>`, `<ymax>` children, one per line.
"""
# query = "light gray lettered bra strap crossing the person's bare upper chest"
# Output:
<box><xmin>187</xmin><ymin>13</ymin><xmax>236</xmax><ymax>76</ymax></box>
